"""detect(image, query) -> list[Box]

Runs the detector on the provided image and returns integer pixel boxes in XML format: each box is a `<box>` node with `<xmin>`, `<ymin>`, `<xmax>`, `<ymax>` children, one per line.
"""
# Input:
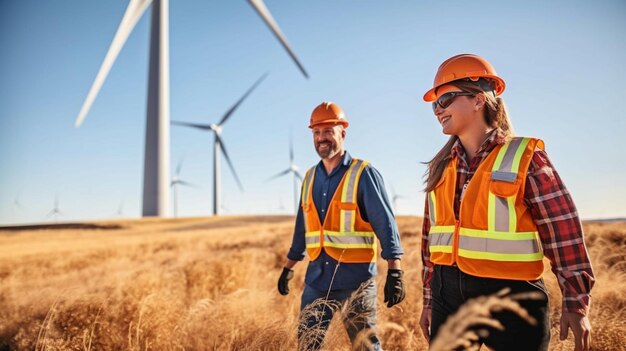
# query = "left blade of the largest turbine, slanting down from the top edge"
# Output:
<box><xmin>75</xmin><ymin>0</ymin><xmax>152</xmax><ymax>127</ymax></box>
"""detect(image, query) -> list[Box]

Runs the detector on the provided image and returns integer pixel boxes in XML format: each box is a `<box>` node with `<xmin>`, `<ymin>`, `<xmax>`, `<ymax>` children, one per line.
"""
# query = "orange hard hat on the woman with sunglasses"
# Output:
<box><xmin>424</xmin><ymin>54</ymin><xmax>506</xmax><ymax>102</ymax></box>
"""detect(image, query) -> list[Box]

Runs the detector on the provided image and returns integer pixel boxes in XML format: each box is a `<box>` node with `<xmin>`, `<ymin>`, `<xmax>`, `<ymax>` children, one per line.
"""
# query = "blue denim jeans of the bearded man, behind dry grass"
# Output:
<box><xmin>298</xmin><ymin>279</ymin><xmax>382</xmax><ymax>351</ymax></box>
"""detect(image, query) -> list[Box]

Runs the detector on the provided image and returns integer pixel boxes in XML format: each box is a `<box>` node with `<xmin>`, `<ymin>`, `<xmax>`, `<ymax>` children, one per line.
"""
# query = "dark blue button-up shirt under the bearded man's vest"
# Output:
<box><xmin>287</xmin><ymin>151</ymin><xmax>403</xmax><ymax>290</ymax></box>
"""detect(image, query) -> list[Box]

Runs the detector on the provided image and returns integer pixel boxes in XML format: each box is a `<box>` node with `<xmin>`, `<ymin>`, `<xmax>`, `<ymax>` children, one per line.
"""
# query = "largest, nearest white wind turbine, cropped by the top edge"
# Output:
<box><xmin>75</xmin><ymin>0</ymin><xmax>308</xmax><ymax>217</ymax></box>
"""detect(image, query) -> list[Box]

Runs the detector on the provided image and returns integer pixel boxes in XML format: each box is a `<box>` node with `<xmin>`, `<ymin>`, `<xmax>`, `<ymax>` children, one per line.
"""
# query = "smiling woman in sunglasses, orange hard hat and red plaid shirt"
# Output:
<box><xmin>420</xmin><ymin>54</ymin><xmax>594</xmax><ymax>350</ymax></box>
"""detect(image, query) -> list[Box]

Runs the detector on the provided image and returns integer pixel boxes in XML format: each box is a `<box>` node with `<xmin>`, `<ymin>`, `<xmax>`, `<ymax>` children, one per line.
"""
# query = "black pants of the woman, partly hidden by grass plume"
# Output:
<box><xmin>430</xmin><ymin>265</ymin><xmax>550</xmax><ymax>351</ymax></box>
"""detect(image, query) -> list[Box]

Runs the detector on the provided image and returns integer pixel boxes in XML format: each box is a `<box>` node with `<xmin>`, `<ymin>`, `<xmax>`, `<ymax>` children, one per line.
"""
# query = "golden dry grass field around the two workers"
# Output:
<box><xmin>0</xmin><ymin>216</ymin><xmax>626</xmax><ymax>351</ymax></box>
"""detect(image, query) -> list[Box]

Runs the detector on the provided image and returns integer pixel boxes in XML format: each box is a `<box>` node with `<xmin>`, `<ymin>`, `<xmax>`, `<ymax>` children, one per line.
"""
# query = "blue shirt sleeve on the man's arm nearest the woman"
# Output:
<box><xmin>357</xmin><ymin>165</ymin><xmax>404</xmax><ymax>260</ymax></box>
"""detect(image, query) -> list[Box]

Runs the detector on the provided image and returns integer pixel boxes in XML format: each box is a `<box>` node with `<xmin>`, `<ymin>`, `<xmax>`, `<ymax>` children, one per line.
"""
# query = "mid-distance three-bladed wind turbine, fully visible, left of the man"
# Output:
<box><xmin>172</xmin><ymin>73</ymin><xmax>267</xmax><ymax>215</ymax></box>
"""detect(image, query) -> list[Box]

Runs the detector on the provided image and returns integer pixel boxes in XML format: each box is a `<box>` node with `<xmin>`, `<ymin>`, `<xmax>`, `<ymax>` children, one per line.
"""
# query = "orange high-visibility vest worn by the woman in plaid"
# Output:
<box><xmin>428</xmin><ymin>137</ymin><xmax>544</xmax><ymax>280</ymax></box>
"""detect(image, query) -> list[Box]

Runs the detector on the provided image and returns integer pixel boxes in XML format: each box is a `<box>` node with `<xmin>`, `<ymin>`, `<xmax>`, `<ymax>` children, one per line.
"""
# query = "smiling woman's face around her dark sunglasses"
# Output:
<box><xmin>434</xmin><ymin>85</ymin><xmax>477</xmax><ymax>136</ymax></box>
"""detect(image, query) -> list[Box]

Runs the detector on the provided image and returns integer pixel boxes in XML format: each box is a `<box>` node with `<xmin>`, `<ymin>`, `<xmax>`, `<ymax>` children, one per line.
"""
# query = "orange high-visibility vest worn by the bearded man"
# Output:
<box><xmin>301</xmin><ymin>158</ymin><xmax>377</xmax><ymax>263</ymax></box>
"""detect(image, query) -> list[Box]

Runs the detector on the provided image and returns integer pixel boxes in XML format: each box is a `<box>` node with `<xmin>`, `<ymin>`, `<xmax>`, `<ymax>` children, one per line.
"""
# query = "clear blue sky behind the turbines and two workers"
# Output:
<box><xmin>0</xmin><ymin>0</ymin><xmax>626</xmax><ymax>225</ymax></box>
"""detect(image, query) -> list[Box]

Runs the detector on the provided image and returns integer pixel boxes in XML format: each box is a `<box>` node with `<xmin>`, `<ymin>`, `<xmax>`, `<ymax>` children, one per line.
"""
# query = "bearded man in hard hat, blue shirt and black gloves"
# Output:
<box><xmin>278</xmin><ymin>102</ymin><xmax>405</xmax><ymax>350</ymax></box>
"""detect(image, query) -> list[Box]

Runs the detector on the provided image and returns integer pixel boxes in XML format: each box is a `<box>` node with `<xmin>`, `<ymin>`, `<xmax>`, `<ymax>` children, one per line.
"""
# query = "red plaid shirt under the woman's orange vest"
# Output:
<box><xmin>422</xmin><ymin>129</ymin><xmax>595</xmax><ymax>315</ymax></box>
